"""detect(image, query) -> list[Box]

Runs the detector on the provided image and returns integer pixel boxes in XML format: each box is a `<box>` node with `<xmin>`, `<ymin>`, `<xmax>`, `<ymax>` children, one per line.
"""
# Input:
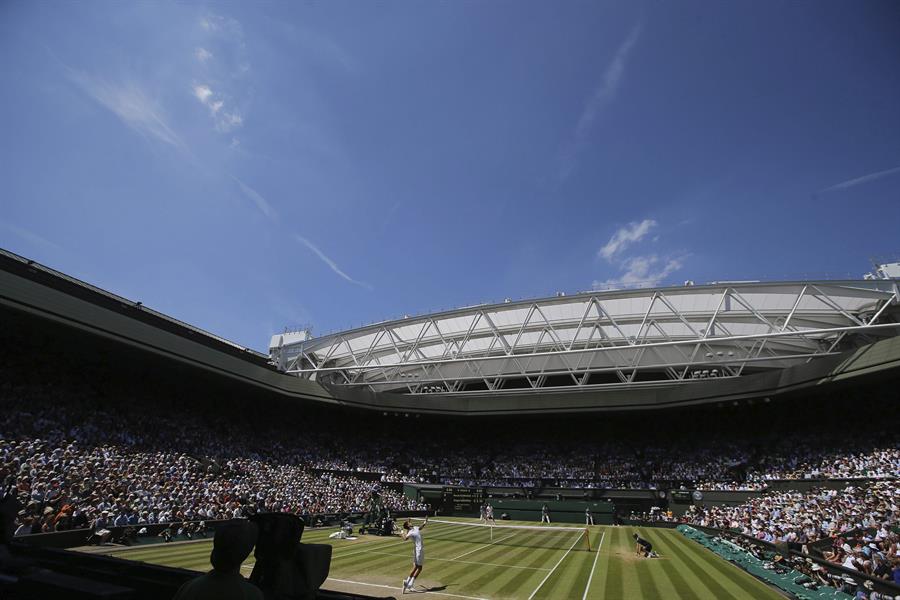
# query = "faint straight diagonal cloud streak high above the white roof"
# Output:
<box><xmin>560</xmin><ymin>23</ymin><xmax>643</xmax><ymax>179</ymax></box>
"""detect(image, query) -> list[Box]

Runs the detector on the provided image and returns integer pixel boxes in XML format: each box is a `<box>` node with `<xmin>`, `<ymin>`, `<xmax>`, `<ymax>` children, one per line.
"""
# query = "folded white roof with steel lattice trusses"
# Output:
<box><xmin>271</xmin><ymin>280</ymin><xmax>900</xmax><ymax>394</ymax></box>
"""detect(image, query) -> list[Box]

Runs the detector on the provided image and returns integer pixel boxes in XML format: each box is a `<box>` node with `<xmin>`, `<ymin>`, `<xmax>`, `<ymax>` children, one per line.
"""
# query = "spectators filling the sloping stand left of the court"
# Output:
<box><xmin>0</xmin><ymin>386</ymin><xmax>425</xmax><ymax>535</ymax></box>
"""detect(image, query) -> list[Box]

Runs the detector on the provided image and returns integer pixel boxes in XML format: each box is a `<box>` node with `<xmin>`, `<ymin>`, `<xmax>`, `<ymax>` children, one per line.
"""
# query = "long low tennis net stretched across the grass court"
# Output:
<box><xmin>413</xmin><ymin>519</ymin><xmax>591</xmax><ymax>551</ymax></box>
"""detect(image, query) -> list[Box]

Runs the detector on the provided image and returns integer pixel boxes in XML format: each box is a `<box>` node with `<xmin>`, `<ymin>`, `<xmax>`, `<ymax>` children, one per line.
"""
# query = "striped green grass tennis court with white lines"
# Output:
<box><xmin>89</xmin><ymin>519</ymin><xmax>782</xmax><ymax>600</ymax></box>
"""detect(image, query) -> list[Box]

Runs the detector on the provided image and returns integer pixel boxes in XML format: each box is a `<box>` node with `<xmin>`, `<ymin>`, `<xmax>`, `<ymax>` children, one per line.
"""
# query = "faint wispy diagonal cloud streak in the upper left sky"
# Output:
<box><xmin>66</xmin><ymin>67</ymin><xmax>187</xmax><ymax>150</ymax></box>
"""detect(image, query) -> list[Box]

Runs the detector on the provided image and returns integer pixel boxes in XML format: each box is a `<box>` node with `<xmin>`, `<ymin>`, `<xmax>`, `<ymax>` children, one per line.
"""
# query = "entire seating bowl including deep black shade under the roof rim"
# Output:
<box><xmin>0</xmin><ymin>251</ymin><xmax>900</xmax><ymax>598</ymax></box>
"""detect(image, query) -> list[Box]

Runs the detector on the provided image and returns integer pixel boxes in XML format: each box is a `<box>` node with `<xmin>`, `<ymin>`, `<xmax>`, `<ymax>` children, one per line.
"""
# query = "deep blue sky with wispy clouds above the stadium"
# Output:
<box><xmin>0</xmin><ymin>0</ymin><xmax>900</xmax><ymax>349</ymax></box>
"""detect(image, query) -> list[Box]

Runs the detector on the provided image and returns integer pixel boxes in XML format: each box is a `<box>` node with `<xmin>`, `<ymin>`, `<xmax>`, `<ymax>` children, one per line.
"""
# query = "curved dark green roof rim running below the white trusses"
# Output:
<box><xmin>0</xmin><ymin>246</ymin><xmax>900</xmax><ymax>417</ymax></box>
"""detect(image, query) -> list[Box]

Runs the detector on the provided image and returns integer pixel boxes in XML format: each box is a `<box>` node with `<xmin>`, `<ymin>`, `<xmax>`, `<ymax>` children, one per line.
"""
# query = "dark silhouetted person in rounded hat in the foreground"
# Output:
<box><xmin>173</xmin><ymin>521</ymin><xmax>263</xmax><ymax>600</ymax></box>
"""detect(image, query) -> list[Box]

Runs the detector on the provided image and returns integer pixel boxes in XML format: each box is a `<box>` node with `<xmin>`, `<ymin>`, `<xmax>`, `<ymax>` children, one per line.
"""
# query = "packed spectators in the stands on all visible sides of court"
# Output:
<box><xmin>0</xmin><ymin>370</ymin><xmax>900</xmax><ymax>578</ymax></box>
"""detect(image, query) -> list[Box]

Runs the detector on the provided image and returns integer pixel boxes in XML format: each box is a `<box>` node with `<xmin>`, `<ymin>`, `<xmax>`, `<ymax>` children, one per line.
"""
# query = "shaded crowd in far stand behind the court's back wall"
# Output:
<box><xmin>392</xmin><ymin>436</ymin><xmax>900</xmax><ymax>491</ymax></box>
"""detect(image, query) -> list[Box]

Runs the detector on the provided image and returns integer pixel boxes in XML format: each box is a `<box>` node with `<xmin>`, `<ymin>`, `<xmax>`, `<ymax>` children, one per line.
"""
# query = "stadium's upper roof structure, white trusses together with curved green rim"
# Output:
<box><xmin>0</xmin><ymin>246</ymin><xmax>900</xmax><ymax>416</ymax></box>
